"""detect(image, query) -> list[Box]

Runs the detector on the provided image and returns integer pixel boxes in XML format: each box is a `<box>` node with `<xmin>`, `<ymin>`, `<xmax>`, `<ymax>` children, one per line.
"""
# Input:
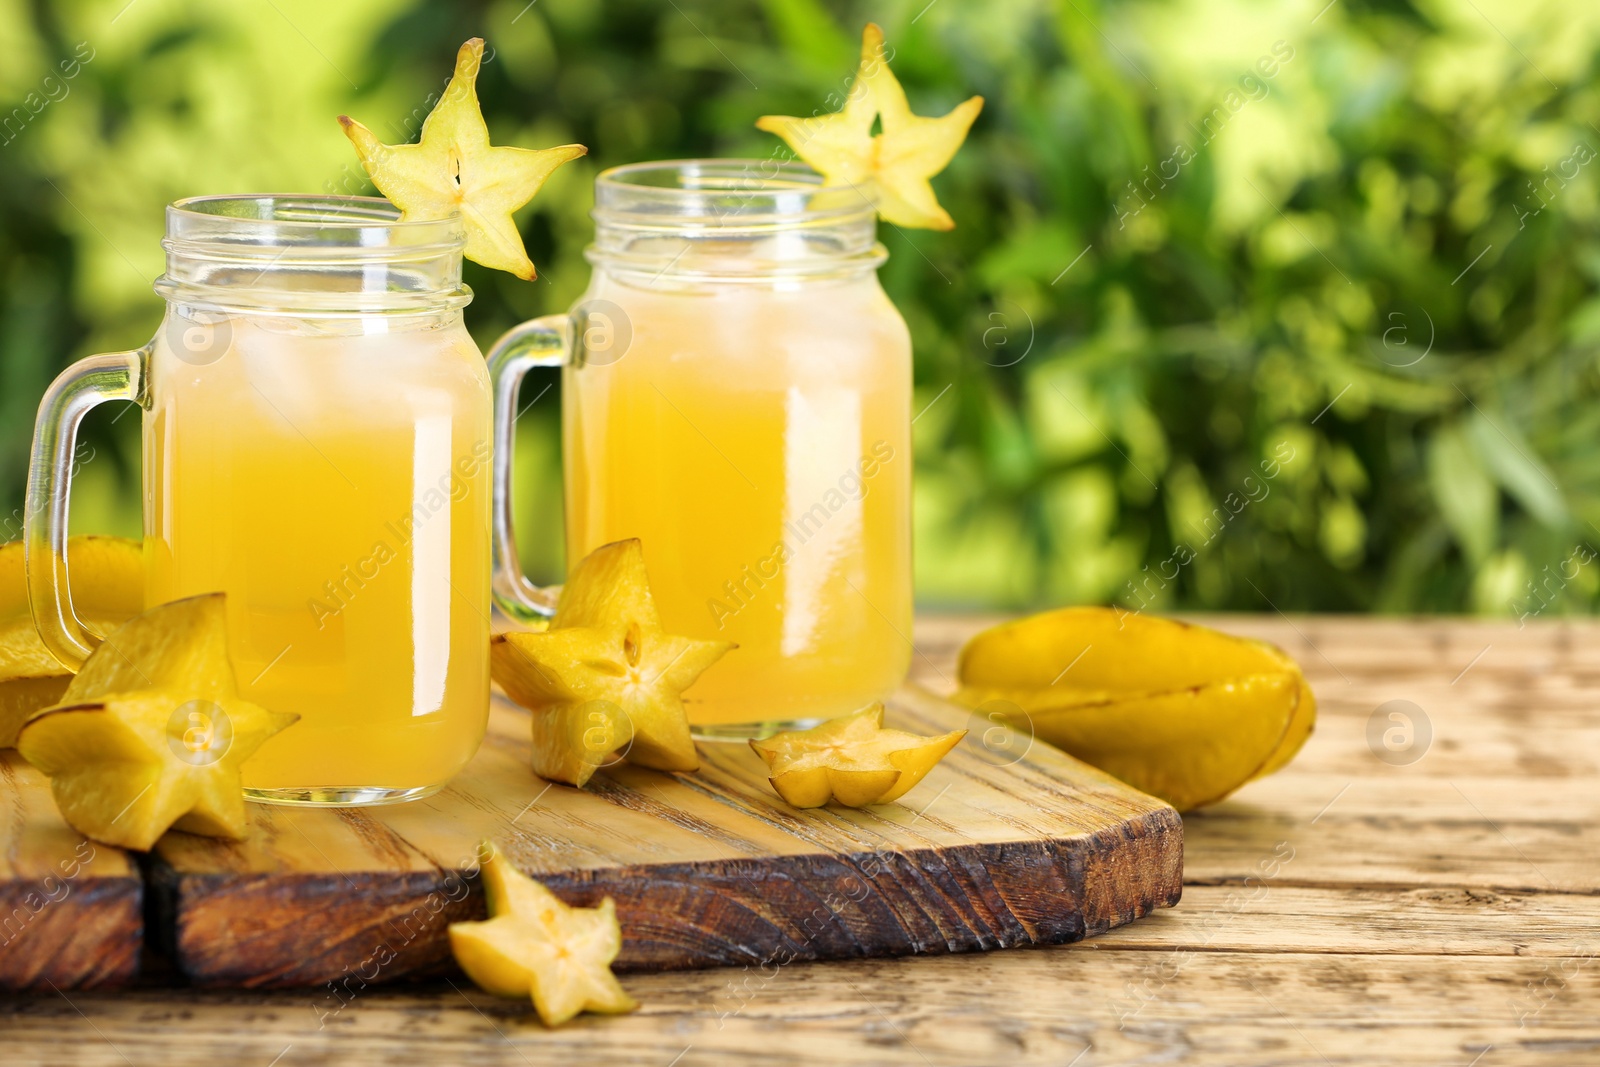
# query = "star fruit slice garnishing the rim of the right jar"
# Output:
<box><xmin>755</xmin><ymin>22</ymin><xmax>984</xmax><ymax>230</ymax></box>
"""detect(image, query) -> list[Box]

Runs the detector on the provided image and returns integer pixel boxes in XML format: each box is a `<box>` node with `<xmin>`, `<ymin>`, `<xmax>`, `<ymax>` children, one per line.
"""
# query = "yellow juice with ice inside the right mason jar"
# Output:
<box><xmin>563</xmin><ymin>270</ymin><xmax>912</xmax><ymax>726</ymax></box>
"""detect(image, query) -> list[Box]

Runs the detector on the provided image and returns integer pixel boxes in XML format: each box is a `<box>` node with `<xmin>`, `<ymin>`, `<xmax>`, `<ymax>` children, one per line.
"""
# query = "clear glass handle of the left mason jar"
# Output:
<box><xmin>22</xmin><ymin>349</ymin><xmax>144</xmax><ymax>670</ymax></box>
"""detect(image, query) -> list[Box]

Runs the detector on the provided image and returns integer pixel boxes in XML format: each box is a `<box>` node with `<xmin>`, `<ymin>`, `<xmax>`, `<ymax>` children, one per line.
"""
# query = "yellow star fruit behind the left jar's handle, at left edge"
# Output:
<box><xmin>0</xmin><ymin>536</ymin><xmax>144</xmax><ymax>749</ymax></box>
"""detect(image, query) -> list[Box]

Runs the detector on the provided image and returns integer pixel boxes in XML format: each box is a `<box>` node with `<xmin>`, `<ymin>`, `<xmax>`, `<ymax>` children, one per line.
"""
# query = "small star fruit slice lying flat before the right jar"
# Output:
<box><xmin>750</xmin><ymin>704</ymin><xmax>966</xmax><ymax>808</ymax></box>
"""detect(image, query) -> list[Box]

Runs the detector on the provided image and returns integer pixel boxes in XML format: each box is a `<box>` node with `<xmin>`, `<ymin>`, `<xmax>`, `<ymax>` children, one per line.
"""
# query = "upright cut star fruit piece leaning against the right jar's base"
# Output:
<box><xmin>490</xmin><ymin>537</ymin><xmax>734</xmax><ymax>785</ymax></box>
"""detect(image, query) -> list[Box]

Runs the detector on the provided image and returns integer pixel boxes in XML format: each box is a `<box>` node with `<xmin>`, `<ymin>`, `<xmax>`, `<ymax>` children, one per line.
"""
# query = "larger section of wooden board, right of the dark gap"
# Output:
<box><xmin>152</xmin><ymin>691</ymin><xmax>1182</xmax><ymax>991</ymax></box>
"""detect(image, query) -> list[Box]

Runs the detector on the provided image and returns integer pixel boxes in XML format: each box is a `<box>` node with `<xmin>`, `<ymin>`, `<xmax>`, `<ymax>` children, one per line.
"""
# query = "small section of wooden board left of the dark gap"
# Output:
<box><xmin>0</xmin><ymin>749</ymin><xmax>144</xmax><ymax>992</ymax></box>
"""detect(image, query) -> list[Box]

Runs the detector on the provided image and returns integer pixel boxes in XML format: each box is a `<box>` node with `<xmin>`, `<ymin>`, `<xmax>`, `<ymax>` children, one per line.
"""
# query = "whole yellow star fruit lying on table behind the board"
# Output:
<box><xmin>957</xmin><ymin>608</ymin><xmax>1317</xmax><ymax>811</ymax></box>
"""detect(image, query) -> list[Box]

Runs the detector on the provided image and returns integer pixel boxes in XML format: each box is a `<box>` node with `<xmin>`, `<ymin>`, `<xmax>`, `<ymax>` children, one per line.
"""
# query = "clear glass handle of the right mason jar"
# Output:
<box><xmin>488</xmin><ymin>315</ymin><xmax>573</xmax><ymax>622</ymax></box>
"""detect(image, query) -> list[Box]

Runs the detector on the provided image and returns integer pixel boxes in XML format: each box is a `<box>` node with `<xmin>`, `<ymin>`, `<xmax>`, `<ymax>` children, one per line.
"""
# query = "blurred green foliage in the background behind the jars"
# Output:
<box><xmin>0</xmin><ymin>0</ymin><xmax>1600</xmax><ymax>614</ymax></box>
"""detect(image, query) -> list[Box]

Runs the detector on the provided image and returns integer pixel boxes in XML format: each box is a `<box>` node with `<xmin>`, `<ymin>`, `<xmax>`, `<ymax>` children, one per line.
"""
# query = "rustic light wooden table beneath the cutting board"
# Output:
<box><xmin>0</xmin><ymin>616</ymin><xmax>1600</xmax><ymax>1067</ymax></box>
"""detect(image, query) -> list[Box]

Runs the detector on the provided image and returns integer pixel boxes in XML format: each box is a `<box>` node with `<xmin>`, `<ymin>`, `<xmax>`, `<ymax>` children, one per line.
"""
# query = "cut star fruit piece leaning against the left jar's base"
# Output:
<box><xmin>16</xmin><ymin>593</ymin><xmax>299</xmax><ymax>851</ymax></box>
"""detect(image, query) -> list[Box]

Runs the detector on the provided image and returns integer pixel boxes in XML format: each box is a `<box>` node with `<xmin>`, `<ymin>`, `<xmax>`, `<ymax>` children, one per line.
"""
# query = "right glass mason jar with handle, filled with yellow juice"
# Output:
<box><xmin>490</xmin><ymin>160</ymin><xmax>912</xmax><ymax>737</ymax></box>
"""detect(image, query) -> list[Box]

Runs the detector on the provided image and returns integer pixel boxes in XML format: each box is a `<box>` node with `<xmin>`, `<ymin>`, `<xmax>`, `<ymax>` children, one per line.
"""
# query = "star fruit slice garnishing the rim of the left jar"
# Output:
<box><xmin>339</xmin><ymin>37</ymin><xmax>589</xmax><ymax>282</ymax></box>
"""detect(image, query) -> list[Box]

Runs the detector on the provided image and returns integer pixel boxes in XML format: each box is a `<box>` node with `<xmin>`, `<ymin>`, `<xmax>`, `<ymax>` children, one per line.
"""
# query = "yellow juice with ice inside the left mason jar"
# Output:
<box><xmin>144</xmin><ymin>317</ymin><xmax>491</xmax><ymax>790</ymax></box>
